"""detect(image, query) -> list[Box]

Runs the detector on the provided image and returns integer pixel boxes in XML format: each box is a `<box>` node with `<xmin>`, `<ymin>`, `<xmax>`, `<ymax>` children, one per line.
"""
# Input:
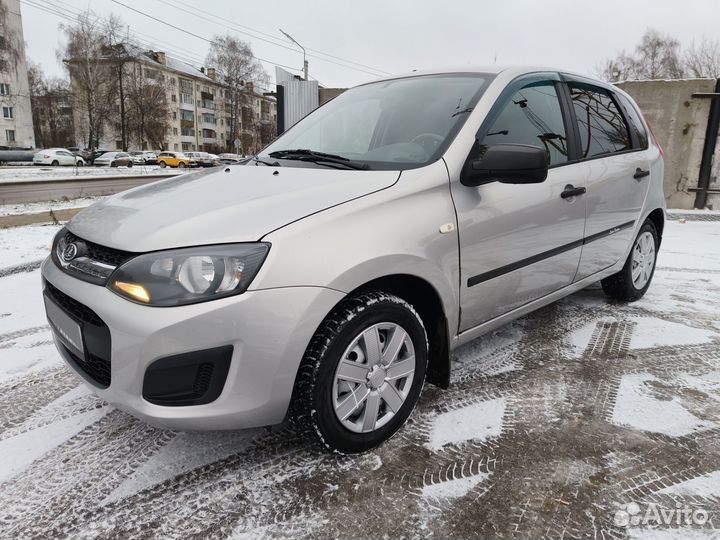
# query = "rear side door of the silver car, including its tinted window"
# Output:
<box><xmin>567</xmin><ymin>80</ymin><xmax>650</xmax><ymax>280</ymax></box>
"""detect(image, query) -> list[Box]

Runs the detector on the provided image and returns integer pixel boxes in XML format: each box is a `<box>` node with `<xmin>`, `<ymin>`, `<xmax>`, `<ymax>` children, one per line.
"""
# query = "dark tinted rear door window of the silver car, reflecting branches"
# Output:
<box><xmin>570</xmin><ymin>84</ymin><xmax>632</xmax><ymax>158</ymax></box>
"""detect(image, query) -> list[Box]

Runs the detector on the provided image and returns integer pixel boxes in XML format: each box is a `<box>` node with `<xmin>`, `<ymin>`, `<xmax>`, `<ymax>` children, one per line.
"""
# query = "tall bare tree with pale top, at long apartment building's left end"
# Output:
<box><xmin>59</xmin><ymin>11</ymin><xmax>117</xmax><ymax>150</ymax></box>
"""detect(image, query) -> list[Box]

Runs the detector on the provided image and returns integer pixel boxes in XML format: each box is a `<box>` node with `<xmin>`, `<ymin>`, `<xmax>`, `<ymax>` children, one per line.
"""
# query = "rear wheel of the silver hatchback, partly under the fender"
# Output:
<box><xmin>600</xmin><ymin>220</ymin><xmax>660</xmax><ymax>302</ymax></box>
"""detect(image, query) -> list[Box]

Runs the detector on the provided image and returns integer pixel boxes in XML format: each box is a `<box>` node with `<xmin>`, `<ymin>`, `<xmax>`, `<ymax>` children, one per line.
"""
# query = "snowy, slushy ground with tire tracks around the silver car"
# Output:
<box><xmin>0</xmin><ymin>217</ymin><xmax>720</xmax><ymax>540</ymax></box>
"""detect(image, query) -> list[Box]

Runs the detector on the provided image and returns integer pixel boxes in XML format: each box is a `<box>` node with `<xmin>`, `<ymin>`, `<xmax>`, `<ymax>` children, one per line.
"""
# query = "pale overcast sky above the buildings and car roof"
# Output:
<box><xmin>21</xmin><ymin>0</ymin><xmax>720</xmax><ymax>87</ymax></box>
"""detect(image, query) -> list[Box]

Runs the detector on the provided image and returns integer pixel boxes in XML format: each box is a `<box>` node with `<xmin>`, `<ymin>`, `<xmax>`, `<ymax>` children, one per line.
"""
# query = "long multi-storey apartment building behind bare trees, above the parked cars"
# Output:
<box><xmin>83</xmin><ymin>45</ymin><xmax>277</xmax><ymax>153</ymax></box>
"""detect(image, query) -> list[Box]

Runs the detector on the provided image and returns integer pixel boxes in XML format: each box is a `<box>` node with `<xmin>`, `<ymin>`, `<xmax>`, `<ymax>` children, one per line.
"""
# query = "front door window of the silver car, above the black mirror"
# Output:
<box><xmin>477</xmin><ymin>81</ymin><xmax>568</xmax><ymax>166</ymax></box>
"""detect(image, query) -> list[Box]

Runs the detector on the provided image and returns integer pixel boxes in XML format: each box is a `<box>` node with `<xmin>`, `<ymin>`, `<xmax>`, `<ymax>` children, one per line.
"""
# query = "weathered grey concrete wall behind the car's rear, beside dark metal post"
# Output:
<box><xmin>616</xmin><ymin>79</ymin><xmax>718</xmax><ymax>208</ymax></box>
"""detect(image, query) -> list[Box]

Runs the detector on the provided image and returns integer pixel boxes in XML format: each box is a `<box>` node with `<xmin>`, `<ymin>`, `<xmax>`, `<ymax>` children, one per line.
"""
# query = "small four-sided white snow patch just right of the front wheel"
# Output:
<box><xmin>426</xmin><ymin>398</ymin><xmax>505</xmax><ymax>450</ymax></box>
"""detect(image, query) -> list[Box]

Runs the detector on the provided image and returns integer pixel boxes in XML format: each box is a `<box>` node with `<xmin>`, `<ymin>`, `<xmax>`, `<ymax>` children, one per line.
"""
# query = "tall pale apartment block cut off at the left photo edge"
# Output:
<box><xmin>0</xmin><ymin>0</ymin><xmax>35</xmax><ymax>148</ymax></box>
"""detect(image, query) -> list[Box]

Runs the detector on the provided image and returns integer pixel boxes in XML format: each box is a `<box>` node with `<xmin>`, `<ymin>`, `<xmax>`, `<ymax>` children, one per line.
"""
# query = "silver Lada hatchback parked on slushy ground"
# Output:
<box><xmin>42</xmin><ymin>67</ymin><xmax>665</xmax><ymax>452</ymax></box>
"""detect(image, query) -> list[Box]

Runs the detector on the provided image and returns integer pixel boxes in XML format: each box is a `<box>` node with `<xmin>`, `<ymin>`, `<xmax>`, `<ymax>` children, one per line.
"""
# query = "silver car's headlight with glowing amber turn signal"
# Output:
<box><xmin>108</xmin><ymin>243</ymin><xmax>270</xmax><ymax>306</ymax></box>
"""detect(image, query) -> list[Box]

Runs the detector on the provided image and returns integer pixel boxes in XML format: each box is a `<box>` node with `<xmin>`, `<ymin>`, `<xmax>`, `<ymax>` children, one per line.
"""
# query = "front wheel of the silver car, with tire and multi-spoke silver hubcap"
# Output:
<box><xmin>291</xmin><ymin>292</ymin><xmax>428</xmax><ymax>454</ymax></box>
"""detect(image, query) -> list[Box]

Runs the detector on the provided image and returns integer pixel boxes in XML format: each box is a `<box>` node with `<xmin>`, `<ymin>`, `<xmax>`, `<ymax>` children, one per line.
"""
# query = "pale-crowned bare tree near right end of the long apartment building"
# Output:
<box><xmin>206</xmin><ymin>35</ymin><xmax>268</xmax><ymax>150</ymax></box>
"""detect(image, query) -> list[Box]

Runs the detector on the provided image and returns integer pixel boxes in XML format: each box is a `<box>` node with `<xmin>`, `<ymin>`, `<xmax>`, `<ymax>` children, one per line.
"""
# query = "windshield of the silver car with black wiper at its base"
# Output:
<box><xmin>260</xmin><ymin>74</ymin><xmax>493</xmax><ymax>169</ymax></box>
